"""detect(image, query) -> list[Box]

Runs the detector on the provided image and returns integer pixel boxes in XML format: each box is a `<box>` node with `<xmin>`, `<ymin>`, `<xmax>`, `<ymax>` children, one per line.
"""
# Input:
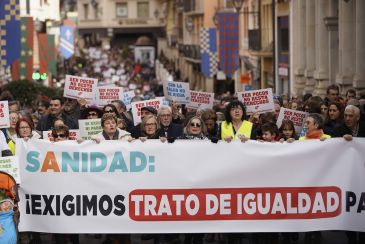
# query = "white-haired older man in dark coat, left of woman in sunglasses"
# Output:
<box><xmin>158</xmin><ymin>107</ymin><xmax>183</xmax><ymax>138</ymax></box>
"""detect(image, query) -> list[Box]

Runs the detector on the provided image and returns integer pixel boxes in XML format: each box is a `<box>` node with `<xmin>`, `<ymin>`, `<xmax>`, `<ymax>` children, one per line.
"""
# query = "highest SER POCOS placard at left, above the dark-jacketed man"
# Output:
<box><xmin>63</xmin><ymin>75</ymin><xmax>98</xmax><ymax>100</ymax></box>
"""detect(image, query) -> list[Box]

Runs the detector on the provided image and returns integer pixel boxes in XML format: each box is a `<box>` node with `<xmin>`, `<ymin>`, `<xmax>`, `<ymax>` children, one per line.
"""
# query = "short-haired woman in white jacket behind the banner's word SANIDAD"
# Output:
<box><xmin>92</xmin><ymin>113</ymin><xmax>131</xmax><ymax>143</ymax></box>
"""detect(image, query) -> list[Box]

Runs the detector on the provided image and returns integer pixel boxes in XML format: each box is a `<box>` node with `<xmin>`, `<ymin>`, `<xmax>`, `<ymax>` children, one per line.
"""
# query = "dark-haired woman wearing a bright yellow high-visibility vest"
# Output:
<box><xmin>220</xmin><ymin>100</ymin><xmax>256</xmax><ymax>142</ymax></box>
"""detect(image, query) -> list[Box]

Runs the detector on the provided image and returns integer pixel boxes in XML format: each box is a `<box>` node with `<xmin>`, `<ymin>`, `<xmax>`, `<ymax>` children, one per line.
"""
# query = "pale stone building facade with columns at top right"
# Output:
<box><xmin>291</xmin><ymin>0</ymin><xmax>365</xmax><ymax>96</ymax></box>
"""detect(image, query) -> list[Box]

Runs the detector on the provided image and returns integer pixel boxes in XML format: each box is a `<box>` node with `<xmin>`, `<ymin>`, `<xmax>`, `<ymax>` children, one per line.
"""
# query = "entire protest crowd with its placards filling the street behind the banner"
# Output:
<box><xmin>0</xmin><ymin>45</ymin><xmax>365</xmax><ymax>244</ymax></box>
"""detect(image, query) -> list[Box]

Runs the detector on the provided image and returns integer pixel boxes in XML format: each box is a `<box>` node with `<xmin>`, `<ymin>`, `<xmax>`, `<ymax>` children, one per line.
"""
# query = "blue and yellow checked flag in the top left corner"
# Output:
<box><xmin>0</xmin><ymin>0</ymin><xmax>20</xmax><ymax>67</ymax></box>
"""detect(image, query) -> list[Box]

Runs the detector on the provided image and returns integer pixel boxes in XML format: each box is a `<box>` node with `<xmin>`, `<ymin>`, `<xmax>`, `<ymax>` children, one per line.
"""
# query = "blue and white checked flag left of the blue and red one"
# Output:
<box><xmin>200</xmin><ymin>27</ymin><xmax>218</xmax><ymax>78</ymax></box>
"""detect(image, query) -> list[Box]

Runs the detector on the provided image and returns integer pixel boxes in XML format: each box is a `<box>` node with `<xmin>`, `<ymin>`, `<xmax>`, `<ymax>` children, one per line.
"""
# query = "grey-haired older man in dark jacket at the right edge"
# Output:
<box><xmin>334</xmin><ymin>105</ymin><xmax>365</xmax><ymax>141</ymax></box>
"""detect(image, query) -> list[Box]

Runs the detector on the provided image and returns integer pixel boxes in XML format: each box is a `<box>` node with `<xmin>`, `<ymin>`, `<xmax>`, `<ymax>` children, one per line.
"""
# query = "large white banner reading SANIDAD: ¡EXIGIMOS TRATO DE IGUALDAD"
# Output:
<box><xmin>16</xmin><ymin>138</ymin><xmax>365</xmax><ymax>233</ymax></box>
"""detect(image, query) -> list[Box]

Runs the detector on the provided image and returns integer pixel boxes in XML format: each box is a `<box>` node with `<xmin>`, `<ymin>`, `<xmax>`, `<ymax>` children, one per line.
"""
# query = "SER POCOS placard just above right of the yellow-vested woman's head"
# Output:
<box><xmin>237</xmin><ymin>88</ymin><xmax>275</xmax><ymax>115</ymax></box>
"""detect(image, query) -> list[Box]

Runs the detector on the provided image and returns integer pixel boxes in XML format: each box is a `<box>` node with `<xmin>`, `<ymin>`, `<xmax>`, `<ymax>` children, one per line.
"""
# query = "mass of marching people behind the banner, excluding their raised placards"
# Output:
<box><xmin>0</xmin><ymin>45</ymin><xmax>365</xmax><ymax>244</ymax></box>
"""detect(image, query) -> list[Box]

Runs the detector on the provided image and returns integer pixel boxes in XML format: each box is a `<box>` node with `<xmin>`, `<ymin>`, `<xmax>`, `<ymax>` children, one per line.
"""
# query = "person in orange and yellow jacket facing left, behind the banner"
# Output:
<box><xmin>299</xmin><ymin>113</ymin><xmax>331</xmax><ymax>141</ymax></box>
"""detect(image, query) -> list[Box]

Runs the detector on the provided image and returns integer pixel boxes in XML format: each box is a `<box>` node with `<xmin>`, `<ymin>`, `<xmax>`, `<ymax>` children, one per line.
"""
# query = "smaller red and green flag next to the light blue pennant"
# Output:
<box><xmin>38</xmin><ymin>34</ymin><xmax>57</xmax><ymax>76</ymax></box>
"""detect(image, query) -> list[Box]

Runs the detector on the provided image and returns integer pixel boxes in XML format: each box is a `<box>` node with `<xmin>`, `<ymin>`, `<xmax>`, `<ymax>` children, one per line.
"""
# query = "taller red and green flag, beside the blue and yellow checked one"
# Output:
<box><xmin>11</xmin><ymin>17</ymin><xmax>34</xmax><ymax>80</ymax></box>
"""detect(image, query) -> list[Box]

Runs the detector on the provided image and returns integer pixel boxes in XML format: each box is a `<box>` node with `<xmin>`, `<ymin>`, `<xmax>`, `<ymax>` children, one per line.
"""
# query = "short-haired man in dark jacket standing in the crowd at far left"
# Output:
<box><xmin>37</xmin><ymin>97</ymin><xmax>79</xmax><ymax>131</ymax></box>
